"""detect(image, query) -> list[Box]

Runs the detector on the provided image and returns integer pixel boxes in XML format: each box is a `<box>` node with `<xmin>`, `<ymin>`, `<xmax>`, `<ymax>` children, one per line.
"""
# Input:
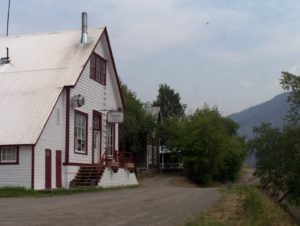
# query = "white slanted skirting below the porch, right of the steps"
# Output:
<box><xmin>98</xmin><ymin>167</ymin><xmax>138</xmax><ymax>188</ymax></box>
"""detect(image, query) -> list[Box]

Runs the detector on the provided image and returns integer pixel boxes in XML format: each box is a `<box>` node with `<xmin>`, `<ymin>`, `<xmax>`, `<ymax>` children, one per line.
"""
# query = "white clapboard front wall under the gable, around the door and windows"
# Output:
<box><xmin>69</xmin><ymin>33</ymin><xmax>121</xmax><ymax>163</ymax></box>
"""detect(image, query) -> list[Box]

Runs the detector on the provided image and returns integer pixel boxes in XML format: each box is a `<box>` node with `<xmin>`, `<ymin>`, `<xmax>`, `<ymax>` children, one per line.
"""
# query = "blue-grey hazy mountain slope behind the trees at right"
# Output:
<box><xmin>227</xmin><ymin>93</ymin><xmax>289</xmax><ymax>139</ymax></box>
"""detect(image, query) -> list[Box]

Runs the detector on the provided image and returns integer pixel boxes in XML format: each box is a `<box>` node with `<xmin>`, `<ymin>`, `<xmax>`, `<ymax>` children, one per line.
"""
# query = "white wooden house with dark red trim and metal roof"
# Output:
<box><xmin>0</xmin><ymin>14</ymin><xmax>137</xmax><ymax>189</ymax></box>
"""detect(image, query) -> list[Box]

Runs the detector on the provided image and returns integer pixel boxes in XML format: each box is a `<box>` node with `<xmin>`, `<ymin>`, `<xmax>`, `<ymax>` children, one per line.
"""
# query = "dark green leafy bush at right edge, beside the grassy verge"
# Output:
<box><xmin>250</xmin><ymin>123</ymin><xmax>300</xmax><ymax>203</ymax></box>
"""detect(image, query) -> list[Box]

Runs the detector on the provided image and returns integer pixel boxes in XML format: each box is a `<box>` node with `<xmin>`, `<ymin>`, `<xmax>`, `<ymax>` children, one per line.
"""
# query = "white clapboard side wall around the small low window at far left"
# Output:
<box><xmin>0</xmin><ymin>146</ymin><xmax>32</xmax><ymax>188</ymax></box>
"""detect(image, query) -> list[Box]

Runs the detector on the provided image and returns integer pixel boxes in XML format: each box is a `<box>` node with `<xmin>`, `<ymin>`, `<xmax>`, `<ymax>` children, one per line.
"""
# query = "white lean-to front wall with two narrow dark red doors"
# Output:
<box><xmin>34</xmin><ymin>90</ymin><xmax>68</xmax><ymax>189</ymax></box>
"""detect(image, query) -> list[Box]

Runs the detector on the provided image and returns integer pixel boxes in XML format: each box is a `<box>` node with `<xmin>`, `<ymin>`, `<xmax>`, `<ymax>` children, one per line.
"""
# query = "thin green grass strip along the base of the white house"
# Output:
<box><xmin>0</xmin><ymin>185</ymin><xmax>139</xmax><ymax>198</ymax></box>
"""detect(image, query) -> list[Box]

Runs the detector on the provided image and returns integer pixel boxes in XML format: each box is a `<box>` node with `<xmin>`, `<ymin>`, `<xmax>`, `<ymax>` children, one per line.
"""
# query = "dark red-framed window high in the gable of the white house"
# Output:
<box><xmin>90</xmin><ymin>53</ymin><xmax>106</xmax><ymax>86</ymax></box>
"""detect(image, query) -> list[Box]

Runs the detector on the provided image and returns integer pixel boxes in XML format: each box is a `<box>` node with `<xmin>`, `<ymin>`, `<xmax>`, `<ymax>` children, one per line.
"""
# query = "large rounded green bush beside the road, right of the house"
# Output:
<box><xmin>181</xmin><ymin>107</ymin><xmax>247</xmax><ymax>185</ymax></box>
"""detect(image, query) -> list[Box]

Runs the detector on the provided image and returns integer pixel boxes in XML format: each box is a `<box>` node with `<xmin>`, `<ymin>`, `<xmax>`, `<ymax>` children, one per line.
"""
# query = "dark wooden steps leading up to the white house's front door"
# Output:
<box><xmin>70</xmin><ymin>165</ymin><xmax>105</xmax><ymax>187</ymax></box>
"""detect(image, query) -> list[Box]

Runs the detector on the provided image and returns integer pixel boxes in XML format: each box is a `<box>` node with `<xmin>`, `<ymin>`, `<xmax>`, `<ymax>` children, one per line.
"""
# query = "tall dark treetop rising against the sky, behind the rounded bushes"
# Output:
<box><xmin>153</xmin><ymin>84</ymin><xmax>186</xmax><ymax>119</ymax></box>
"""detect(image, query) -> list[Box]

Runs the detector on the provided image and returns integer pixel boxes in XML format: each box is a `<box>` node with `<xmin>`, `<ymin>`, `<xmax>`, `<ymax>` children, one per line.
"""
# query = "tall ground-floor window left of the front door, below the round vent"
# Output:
<box><xmin>74</xmin><ymin>111</ymin><xmax>87</xmax><ymax>154</ymax></box>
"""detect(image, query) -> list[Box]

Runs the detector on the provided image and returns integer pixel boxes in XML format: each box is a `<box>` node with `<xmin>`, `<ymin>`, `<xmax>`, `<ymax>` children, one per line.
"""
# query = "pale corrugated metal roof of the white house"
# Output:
<box><xmin>0</xmin><ymin>28</ymin><xmax>123</xmax><ymax>145</ymax></box>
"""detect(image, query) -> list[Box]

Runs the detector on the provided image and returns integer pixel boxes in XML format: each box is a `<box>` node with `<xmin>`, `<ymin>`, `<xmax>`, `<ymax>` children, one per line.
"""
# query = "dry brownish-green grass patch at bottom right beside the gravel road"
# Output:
<box><xmin>186</xmin><ymin>186</ymin><xmax>296</xmax><ymax>226</ymax></box>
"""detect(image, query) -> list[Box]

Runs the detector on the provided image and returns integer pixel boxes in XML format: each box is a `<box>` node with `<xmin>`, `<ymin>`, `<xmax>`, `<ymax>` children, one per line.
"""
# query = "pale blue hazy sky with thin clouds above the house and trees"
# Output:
<box><xmin>0</xmin><ymin>0</ymin><xmax>300</xmax><ymax>115</ymax></box>
